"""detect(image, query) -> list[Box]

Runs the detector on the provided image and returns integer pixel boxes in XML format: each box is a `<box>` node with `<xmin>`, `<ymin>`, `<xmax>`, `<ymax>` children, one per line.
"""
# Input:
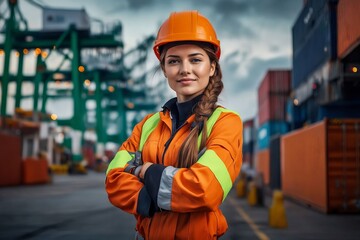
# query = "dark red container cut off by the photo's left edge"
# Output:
<box><xmin>0</xmin><ymin>130</ymin><xmax>22</xmax><ymax>186</ymax></box>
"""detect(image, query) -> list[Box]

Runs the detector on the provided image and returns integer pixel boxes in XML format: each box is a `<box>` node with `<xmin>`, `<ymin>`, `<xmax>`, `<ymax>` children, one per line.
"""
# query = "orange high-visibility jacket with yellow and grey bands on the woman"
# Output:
<box><xmin>106</xmin><ymin>107</ymin><xmax>242</xmax><ymax>239</ymax></box>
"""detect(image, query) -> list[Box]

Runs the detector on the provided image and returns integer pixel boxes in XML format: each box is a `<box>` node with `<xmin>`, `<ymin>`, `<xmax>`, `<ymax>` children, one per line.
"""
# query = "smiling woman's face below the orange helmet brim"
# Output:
<box><xmin>163</xmin><ymin>44</ymin><xmax>215</xmax><ymax>102</ymax></box>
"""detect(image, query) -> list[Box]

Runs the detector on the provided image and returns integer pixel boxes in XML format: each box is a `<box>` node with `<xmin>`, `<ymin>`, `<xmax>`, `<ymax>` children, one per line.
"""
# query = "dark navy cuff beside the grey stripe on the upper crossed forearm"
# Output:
<box><xmin>144</xmin><ymin>164</ymin><xmax>165</xmax><ymax>206</ymax></box>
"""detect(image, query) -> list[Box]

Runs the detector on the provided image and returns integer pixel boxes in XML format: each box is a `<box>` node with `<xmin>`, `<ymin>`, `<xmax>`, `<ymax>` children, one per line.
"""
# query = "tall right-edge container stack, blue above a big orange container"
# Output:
<box><xmin>278</xmin><ymin>0</ymin><xmax>360</xmax><ymax>213</ymax></box>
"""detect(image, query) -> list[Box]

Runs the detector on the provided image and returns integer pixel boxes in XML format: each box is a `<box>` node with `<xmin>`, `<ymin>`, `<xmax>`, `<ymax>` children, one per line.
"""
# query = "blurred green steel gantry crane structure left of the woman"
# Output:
<box><xmin>0</xmin><ymin>0</ymin><xmax>160</xmax><ymax>176</ymax></box>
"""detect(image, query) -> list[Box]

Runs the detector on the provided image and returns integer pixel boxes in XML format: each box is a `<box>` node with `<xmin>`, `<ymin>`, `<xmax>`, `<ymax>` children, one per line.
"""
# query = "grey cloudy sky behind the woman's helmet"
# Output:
<box><xmin>1</xmin><ymin>0</ymin><xmax>303</xmax><ymax>120</ymax></box>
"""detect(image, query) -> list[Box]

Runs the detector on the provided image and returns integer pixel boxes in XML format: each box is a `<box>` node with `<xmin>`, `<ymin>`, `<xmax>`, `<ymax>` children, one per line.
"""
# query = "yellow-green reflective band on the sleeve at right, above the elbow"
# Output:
<box><xmin>197</xmin><ymin>150</ymin><xmax>232</xmax><ymax>201</ymax></box>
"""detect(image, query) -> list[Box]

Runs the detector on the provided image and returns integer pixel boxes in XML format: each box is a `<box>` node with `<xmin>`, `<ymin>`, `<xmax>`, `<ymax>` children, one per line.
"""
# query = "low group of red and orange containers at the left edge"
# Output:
<box><xmin>0</xmin><ymin>118</ymin><xmax>50</xmax><ymax>186</ymax></box>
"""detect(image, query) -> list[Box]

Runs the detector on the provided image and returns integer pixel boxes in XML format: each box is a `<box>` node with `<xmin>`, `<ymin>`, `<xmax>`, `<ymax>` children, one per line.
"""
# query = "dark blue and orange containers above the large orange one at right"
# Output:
<box><xmin>291</xmin><ymin>0</ymin><xmax>360</xmax><ymax>128</ymax></box>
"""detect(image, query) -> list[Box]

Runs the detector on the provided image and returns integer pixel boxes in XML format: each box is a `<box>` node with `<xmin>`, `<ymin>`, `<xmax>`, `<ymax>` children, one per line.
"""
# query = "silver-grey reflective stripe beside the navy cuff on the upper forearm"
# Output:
<box><xmin>157</xmin><ymin>166</ymin><xmax>179</xmax><ymax>210</ymax></box>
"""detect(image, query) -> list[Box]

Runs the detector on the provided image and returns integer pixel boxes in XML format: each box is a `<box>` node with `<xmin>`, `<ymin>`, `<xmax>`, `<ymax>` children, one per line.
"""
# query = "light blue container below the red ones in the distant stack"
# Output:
<box><xmin>257</xmin><ymin>121</ymin><xmax>289</xmax><ymax>150</ymax></box>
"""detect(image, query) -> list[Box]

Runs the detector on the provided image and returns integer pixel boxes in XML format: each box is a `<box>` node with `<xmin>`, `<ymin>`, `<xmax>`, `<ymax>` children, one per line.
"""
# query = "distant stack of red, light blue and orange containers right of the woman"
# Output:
<box><xmin>256</xmin><ymin>70</ymin><xmax>291</xmax><ymax>184</ymax></box>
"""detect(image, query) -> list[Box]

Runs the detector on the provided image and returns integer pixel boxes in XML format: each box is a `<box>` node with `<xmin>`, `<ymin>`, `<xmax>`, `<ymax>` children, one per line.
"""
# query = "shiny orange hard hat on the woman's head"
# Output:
<box><xmin>153</xmin><ymin>11</ymin><xmax>221</xmax><ymax>60</ymax></box>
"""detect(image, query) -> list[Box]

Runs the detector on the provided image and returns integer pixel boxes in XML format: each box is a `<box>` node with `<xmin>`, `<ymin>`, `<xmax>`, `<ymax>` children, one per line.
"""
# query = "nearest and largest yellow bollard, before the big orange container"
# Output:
<box><xmin>269</xmin><ymin>190</ymin><xmax>288</xmax><ymax>228</ymax></box>
